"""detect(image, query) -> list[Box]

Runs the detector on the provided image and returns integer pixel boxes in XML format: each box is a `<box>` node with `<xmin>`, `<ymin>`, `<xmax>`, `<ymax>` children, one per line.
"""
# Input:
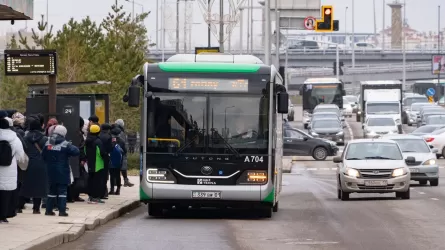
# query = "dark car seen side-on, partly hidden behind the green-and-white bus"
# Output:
<box><xmin>283</xmin><ymin>126</ymin><xmax>338</xmax><ymax>161</ymax></box>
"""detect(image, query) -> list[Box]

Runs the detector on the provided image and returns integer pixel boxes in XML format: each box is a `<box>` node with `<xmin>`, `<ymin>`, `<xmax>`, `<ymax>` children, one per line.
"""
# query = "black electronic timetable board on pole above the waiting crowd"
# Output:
<box><xmin>5</xmin><ymin>50</ymin><xmax>57</xmax><ymax>76</ymax></box>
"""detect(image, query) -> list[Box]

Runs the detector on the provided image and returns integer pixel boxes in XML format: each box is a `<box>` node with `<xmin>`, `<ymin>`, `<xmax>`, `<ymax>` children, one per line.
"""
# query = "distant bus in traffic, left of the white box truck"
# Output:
<box><xmin>300</xmin><ymin>78</ymin><xmax>346</xmax><ymax>128</ymax></box>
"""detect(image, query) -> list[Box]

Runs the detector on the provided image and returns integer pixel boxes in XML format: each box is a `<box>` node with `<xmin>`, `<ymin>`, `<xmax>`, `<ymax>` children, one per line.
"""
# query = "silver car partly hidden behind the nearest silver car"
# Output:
<box><xmin>385</xmin><ymin>135</ymin><xmax>439</xmax><ymax>186</ymax></box>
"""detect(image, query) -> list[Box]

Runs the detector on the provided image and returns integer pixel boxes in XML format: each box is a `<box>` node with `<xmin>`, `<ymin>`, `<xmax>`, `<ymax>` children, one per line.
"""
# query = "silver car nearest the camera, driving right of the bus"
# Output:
<box><xmin>334</xmin><ymin>139</ymin><xmax>416</xmax><ymax>201</ymax></box>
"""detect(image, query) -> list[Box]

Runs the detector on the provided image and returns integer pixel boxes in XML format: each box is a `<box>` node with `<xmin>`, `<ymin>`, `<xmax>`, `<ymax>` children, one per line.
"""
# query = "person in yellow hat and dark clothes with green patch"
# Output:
<box><xmin>85</xmin><ymin>124</ymin><xmax>107</xmax><ymax>204</ymax></box>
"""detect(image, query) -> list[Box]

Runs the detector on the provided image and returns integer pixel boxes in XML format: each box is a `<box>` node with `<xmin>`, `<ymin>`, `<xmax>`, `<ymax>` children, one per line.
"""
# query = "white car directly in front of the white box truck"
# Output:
<box><xmin>363</xmin><ymin>115</ymin><xmax>399</xmax><ymax>138</ymax></box>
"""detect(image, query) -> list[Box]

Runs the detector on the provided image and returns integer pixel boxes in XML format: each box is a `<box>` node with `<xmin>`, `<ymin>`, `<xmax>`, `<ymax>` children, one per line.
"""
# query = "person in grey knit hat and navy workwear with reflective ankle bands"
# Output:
<box><xmin>42</xmin><ymin>125</ymin><xmax>80</xmax><ymax>216</ymax></box>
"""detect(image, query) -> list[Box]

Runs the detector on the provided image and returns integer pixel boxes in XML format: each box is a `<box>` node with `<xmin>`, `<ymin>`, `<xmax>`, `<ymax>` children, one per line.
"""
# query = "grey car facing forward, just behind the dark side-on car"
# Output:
<box><xmin>309</xmin><ymin>118</ymin><xmax>345</xmax><ymax>145</ymax></box>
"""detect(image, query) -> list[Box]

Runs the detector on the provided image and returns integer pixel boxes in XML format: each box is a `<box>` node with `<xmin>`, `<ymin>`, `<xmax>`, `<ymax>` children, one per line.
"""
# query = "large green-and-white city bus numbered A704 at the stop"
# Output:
<box><xmin>124</xmin><ymin>53</ymin><xmax>289</xmax><ymax>218</ymax></box>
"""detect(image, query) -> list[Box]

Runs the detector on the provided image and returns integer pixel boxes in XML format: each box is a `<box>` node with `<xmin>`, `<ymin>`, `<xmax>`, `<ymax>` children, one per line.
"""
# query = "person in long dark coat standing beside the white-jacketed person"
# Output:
<box><xmin>19</xmin><ymin>118</ymin><xmax>48</xmax><ymax>214</ymax></box>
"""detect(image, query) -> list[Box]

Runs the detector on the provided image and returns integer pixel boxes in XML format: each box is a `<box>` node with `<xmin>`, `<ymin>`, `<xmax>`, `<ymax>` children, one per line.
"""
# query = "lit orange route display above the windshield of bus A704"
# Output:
<box><xmin>168</xmin><ymin>77</ymin><xmax>249</xmax><ymax>92</ymax></box>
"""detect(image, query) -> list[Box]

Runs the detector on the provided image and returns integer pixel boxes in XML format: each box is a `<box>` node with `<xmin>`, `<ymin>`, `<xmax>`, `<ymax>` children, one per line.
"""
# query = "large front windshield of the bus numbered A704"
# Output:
<box><xmin>147</xmin><ymin>93</ymin><xmax>268</xmax><ymax>154</ymax></box>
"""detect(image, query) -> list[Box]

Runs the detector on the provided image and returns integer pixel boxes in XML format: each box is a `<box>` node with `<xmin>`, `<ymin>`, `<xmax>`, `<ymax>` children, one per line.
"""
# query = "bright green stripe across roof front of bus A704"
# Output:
<box><xmin>158</xmin><ymin>62</ymin><xmax>261</xmax><ymax>73</ymax></box>
